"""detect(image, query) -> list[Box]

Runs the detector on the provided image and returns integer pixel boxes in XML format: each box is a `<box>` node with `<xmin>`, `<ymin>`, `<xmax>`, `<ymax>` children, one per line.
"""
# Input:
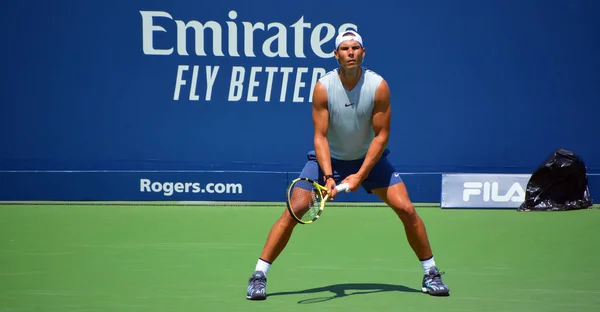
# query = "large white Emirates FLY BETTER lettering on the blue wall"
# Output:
<box><xmin>139</xmin><ymin>9</ymin><xmax>358</xmax><ymax>104</ymax></box>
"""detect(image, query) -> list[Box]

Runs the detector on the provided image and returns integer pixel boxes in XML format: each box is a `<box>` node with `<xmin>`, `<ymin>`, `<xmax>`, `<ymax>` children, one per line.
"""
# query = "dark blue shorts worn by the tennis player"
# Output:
<box><xmin>300</xmin><ymin>149</ymin><xmax>402</xmax><ymax>194</ymax></box>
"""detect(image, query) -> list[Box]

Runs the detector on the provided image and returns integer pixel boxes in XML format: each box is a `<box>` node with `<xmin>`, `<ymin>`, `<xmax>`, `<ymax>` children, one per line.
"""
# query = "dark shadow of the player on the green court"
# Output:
<box><xmin>268</xmin><ymin>283</ymin><xmax>421</xmax><ymax>304</ymax></box>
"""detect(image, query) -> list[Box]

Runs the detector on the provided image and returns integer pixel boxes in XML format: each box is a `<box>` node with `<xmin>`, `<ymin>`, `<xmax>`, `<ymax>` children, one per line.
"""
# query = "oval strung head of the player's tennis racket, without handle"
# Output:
<box><xmin>288</xmin><ymin>180</ymin><xmax>322</xmax><ymax>222</ymax></box>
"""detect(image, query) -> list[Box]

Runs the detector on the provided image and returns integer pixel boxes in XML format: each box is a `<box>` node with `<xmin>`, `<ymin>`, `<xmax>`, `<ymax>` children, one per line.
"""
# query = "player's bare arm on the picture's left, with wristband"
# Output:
<box><xmin>312</xmin><ymin>82</ymin><xmax>335</xmax><ymax>188</ymax></box>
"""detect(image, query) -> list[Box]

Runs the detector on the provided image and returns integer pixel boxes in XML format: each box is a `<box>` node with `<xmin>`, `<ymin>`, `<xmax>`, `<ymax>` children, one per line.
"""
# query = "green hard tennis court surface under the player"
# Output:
<box><xmin>0</xmin><ymin>204</ymin><xmax>600</xmax><ymax>312</ymax></box>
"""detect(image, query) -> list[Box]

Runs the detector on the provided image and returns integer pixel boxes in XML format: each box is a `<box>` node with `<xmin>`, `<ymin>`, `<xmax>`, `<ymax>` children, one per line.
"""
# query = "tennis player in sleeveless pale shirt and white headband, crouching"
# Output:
<box><xmin>246</xmin><ymin>31</ymin><xmax>450</xmax><ymax>300</ymax></box>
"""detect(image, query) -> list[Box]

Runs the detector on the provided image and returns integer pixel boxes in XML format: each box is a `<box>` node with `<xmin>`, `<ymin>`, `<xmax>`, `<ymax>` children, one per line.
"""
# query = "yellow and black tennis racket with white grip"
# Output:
<box><xmin>286</xmin><ymin>178</ymin><xmax>348</xmax><ymax>224</ymax></box>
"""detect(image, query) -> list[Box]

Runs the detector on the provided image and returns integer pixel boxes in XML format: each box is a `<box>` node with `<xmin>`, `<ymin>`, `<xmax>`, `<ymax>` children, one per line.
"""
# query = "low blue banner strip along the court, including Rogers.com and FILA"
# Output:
<box><xmin>0</xmin><ymin>171</ymin><xmax>600</xmax><ymax>208</ymax></box>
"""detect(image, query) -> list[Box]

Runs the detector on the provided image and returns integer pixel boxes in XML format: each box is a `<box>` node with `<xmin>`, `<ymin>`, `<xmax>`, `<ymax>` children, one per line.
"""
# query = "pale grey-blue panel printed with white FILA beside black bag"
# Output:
<box><xmin>441</xmin><ymin>174</ymin><xmax>531</xmax><ymax>208</ymax></box>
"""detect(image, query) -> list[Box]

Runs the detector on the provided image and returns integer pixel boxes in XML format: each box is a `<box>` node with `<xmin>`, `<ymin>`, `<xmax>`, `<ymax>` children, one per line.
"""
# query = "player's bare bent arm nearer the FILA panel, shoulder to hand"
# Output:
<box><xmin>346</xmin><ymin>80</ymin><xmax>392</xmax><ymax>191</ymax></box>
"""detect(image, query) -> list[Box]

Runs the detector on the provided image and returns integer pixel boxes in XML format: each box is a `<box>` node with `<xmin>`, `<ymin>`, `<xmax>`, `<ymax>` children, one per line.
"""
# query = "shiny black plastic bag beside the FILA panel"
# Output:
<box><xmin>518</xmin><ymin>149</ymin><xmax>593</xmax><ymax>211</ymax></box>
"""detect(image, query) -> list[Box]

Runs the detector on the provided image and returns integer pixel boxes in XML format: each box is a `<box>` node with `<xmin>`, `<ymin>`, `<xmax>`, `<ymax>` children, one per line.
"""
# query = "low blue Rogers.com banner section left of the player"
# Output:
<box><xmin>0</xmin><ymin>171</ymin><xmax>287</xmax><ymax>201</ymax></box>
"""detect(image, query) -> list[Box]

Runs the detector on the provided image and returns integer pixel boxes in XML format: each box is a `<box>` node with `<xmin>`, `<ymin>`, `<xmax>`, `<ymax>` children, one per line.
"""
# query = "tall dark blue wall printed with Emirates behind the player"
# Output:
<box><xmin>0</xmin><ymin>0</ymin><xmax>600</xmax><ymax>200</ymax></box>
